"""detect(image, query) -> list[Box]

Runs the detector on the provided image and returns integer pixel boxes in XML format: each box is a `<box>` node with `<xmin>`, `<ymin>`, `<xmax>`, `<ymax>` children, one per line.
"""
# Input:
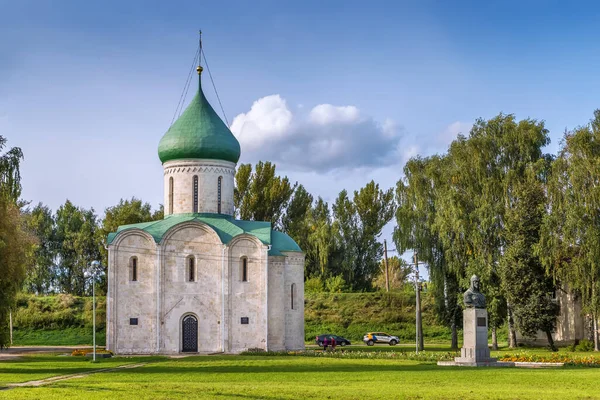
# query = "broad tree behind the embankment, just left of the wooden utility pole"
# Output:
<box><xmin>333</xmin><ymin>181</ymin><xmax>395</xmax><ymax>291</ymax></box>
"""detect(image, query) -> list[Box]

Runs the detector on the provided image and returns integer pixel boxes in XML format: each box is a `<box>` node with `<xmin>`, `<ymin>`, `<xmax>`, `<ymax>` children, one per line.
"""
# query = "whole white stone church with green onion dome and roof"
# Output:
<box><xmin>106</xmin><ymin>61</ymin><xmax>304</xmax><ymax>354</ymax></box>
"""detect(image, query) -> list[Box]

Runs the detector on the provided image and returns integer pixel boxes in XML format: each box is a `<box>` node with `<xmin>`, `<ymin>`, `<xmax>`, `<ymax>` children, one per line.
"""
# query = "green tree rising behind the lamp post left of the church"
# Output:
<box><xmin>55</xmin><ymin>200</ymin><xmax>100</xmax><ymax>296</ymax></box>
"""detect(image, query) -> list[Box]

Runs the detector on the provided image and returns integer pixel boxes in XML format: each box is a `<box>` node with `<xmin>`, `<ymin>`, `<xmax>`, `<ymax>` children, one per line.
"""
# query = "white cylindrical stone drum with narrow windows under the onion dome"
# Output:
<box><xmin>163</xmin><ymin>160</ymin><xmax>235</xmax><ymax>215</ymax></box>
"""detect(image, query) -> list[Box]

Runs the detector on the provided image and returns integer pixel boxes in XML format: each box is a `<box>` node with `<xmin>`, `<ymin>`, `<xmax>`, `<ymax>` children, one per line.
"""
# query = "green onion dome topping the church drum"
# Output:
<box><xmin>158</xmin><ymin>77</ymin><xmax>240</xmax><ymax>163</ymax></box>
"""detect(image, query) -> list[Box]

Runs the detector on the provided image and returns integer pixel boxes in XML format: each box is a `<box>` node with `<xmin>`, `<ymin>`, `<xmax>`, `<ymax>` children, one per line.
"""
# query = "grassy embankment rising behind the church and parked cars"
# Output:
<box><xmin>13</xmin><ymin>292</ymin><xmax>450</xmax><ymax>346</ymax></box>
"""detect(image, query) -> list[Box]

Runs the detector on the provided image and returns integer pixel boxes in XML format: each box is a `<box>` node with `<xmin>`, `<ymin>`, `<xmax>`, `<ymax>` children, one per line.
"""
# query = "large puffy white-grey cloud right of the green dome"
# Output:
<box><xmin>231</xmin><ymin>95</ymin><xmax>404</xmax><ymax>172</ymax></box>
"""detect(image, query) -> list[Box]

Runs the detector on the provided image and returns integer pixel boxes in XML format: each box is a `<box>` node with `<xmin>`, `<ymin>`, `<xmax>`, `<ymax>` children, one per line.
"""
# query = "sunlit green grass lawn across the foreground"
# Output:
<box><xmin>0</xmin><ymin>356</ymin><xmax>600</xmax><ymax>400</ymax></box>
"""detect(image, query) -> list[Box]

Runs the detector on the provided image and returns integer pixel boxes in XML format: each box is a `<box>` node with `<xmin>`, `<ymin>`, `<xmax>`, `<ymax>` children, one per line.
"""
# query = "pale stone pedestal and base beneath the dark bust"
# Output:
<box><xmin>438</xmin><ymin>308</ymin><xmax>515</xmax><ymax>367</ymax></box>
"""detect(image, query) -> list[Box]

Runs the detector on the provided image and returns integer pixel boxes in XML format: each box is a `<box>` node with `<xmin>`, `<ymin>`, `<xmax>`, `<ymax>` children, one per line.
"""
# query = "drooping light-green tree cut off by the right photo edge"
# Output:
<box><xmin>537</xmin><ymin>110</ymin><xmax>600</xmax><ymax>351</ymax></box>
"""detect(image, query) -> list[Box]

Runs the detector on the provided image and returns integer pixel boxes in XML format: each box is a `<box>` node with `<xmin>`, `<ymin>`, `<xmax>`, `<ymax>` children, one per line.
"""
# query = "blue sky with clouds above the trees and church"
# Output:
<box><xmin>0</xmin><ymin>1</ymin><xmax>600</xmax><ymax>268</ymax></box>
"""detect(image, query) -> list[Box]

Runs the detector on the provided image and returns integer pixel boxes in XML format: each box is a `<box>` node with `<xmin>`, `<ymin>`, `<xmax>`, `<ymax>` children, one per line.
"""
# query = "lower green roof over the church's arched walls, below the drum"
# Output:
<box><xmin>107</xmin><ymin>214</ymin><xmax>302</xmax><ymax>256</ymax></box>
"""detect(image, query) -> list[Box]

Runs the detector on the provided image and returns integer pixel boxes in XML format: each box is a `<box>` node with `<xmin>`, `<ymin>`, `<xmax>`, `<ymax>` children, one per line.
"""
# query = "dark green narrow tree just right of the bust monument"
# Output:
<box><xmin>498</xmin><ymin>167</ymin><xmax>559</xmax><ymax>351</ymax></box>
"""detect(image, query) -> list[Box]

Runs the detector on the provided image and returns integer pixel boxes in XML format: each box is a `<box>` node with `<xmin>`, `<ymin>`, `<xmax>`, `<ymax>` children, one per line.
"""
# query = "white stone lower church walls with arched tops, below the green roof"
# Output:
<box><xmin>107</xmin><ymin>222</ymin><xmax>304</xmax><ymax>354</ymax></box>
